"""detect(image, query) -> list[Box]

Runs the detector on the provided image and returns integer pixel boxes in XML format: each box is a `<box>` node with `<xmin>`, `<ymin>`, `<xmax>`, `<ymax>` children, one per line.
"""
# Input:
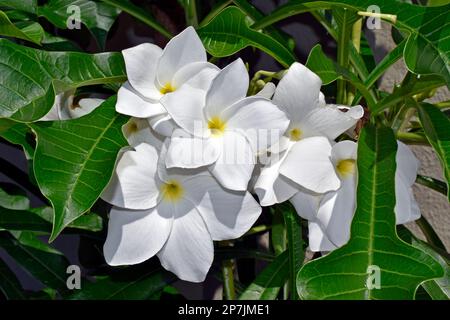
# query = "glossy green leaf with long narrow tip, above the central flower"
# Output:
<box><xmin>197</xmin><ymin>6</ymin><xmax>295</xmax><ymax>67</ymax></box>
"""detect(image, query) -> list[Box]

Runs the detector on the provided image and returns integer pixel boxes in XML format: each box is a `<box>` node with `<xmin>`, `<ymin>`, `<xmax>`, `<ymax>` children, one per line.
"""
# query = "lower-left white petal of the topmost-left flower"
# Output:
<box><xmin>116</xmin><ymin>82</ymin><xmax>166</xmax><ymax>118</ymax></box>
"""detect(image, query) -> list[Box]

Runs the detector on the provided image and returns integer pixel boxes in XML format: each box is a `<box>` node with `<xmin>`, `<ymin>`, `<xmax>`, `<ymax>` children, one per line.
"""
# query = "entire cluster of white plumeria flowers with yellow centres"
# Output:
<box><xmin>95</xmin><ymin>27</ymin><xmax>420</xmax><ymax>282</ymax></box>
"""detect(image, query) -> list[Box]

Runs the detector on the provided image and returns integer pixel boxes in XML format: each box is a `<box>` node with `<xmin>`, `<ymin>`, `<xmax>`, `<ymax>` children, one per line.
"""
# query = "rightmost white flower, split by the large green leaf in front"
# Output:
<box><xmin>291</xmin><ymin>141</ymin><xmax>420</xmax><ymax>251</ymax></box>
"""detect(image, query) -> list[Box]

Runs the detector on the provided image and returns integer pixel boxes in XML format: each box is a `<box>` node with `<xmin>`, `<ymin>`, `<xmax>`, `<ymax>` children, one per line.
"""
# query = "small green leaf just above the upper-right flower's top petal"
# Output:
<box><xmin>306</xmin><ymin>44</ymin><xmax>375</xmax><ymax>109</ymax></box>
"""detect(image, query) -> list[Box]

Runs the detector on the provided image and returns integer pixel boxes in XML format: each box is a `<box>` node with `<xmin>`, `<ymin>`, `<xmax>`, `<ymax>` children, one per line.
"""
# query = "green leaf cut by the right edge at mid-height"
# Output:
<box><xmin>417</xmin><ymin>103</ymin><xmax>450</xmax><ymax>201</ymax></box>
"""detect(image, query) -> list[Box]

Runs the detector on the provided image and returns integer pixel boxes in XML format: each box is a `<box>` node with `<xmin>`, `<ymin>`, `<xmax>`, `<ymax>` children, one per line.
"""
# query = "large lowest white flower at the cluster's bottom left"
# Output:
<box><xmin>102</xmin><ymin>135</ymin><xmax>261</xmax><ymax>282</ymax></box>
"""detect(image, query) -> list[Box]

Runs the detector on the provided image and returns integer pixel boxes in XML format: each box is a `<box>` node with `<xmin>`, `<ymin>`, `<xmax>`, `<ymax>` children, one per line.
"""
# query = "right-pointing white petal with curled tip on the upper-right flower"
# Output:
<box><xmin>302</xmin><ymin>105</ymin><xmax>364</xmax><ymax>140</ymax></box>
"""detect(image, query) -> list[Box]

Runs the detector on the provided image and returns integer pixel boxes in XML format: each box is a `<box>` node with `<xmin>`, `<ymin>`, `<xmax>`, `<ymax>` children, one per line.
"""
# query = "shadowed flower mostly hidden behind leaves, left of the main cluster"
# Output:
<box><xmin>40</xmin><ymin>90</ymin><xmax>105</xmax><ymax>121</ymax></box>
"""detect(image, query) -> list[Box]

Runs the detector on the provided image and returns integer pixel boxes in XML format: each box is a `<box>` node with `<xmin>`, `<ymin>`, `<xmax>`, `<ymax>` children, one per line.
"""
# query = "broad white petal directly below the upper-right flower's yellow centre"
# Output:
<box><xmin>280</xmin><ymin>137</ymin><xmax>340</xmax><ymax>193</ymax></box>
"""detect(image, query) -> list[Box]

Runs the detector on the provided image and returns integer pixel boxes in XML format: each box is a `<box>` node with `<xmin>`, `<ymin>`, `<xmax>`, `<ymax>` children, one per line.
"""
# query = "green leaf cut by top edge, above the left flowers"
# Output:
<box><xmin>38</xmin><ymin>0</ymin><xmax>120</xmax><ymax>48</ymax></box>
